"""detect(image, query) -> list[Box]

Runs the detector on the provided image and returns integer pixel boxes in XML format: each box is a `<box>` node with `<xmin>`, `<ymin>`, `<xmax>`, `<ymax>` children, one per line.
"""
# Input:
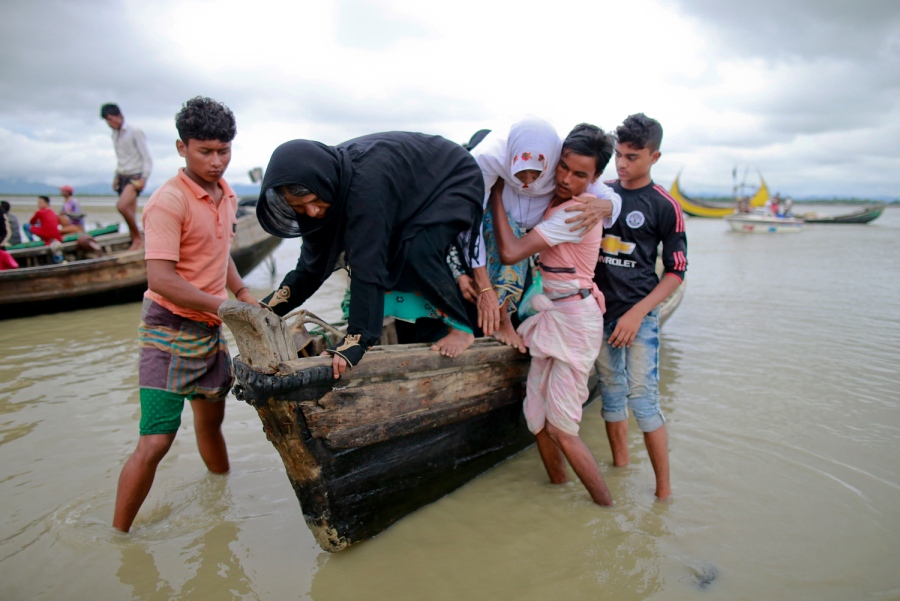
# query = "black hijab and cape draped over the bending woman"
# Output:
<box><xmin>256</xmin><ymin>132</ymin><xmax>484</xmax><ymax>289</ymax></box>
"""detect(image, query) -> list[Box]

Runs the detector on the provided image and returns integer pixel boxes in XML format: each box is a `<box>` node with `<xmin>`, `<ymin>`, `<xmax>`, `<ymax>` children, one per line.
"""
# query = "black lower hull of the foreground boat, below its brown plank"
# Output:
<box><xmin>236</xmin><ymin>350</ymin><xmax>534</xmax><ymax>552</ymax></box>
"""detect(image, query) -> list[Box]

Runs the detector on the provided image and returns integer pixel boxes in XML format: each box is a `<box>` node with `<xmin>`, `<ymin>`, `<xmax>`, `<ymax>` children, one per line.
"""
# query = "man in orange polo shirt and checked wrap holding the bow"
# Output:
<box><xmin>113</xmin><ymin>96</ymin><xmax>259</xmax><ymax>532</ymax></box>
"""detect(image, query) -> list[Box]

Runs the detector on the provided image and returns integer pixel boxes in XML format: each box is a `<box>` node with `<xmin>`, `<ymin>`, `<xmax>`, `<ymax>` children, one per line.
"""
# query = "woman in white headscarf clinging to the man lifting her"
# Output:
<box><xmin>455</xmin><ymin>115</ymin><xmax>621</xmax><ymax>353</ymax></box>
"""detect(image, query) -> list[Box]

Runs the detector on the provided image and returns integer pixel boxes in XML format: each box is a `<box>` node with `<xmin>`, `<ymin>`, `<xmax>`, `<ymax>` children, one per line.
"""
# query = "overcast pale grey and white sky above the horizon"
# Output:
<box><xmin>0</xmin><ymin>0</ymin><xmax>900</xmax><ymax>197</ymax></box>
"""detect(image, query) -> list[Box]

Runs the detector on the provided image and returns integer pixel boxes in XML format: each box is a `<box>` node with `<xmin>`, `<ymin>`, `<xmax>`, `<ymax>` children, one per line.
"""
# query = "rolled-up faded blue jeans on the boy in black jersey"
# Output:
<box><xmin>595</xmin><ymin>309</ymin><xmax>666</xmax><ymax>432</ymax></box>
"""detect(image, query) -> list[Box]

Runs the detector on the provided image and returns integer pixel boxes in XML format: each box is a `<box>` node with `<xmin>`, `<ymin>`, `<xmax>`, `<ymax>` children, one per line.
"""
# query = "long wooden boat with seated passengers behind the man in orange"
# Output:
<box><xmin>0</xmin><ymin>201</ymin><xmax>281</xmax><ymax>319</ymax></box>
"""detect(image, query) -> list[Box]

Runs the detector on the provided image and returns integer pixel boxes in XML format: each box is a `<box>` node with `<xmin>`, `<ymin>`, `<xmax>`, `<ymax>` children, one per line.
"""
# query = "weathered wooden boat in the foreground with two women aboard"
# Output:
<box><xmin>219</xmin><ymin>274</ymin><xmax>684</xmax><ymax>552</ymax></box>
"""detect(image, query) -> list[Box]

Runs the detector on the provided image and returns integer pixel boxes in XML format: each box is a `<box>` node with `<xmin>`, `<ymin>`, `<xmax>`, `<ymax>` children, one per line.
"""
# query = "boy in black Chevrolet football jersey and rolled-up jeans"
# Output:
<box><xmin>594</xmin><ymin>113</ymin><xmax>687</xmax><ymax>500</ymax></box>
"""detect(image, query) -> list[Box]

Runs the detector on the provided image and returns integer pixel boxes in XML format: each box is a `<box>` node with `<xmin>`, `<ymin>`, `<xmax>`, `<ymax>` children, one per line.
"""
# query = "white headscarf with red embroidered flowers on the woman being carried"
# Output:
<box><xmin>472</xmin><ymin>115</ymin><xmax>562</xmax><ymax>206</ymax></box>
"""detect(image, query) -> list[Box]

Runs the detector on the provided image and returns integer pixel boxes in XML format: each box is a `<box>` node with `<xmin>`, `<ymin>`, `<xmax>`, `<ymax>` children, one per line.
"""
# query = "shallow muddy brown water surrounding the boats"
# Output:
<box><xmin>0</xmin><ymin>207</ymin><xmax>900</xmax><ymax>601</ymax></box>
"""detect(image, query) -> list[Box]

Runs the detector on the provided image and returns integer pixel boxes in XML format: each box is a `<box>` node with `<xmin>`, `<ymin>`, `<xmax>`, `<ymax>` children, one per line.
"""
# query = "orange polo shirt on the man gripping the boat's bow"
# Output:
<box><xmin>143</xmin><ymin>169</ymin><xmax>237</xmax><ymax>324</ymax></box>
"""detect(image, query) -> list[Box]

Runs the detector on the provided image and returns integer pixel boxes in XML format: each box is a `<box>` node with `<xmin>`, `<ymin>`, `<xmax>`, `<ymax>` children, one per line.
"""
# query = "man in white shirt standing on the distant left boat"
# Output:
<box><xmin>100</xmin><ymin>103</ymin><xmax>153</xmax><ymax>250</ymax></box>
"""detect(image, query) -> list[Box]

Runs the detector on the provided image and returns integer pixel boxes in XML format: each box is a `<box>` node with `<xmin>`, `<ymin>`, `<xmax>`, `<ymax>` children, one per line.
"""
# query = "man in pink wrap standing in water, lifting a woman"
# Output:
<box><xmin>490</xmin><ymin>123</ymin><xmax>613</xmax><ymax>505</ymax></box>
